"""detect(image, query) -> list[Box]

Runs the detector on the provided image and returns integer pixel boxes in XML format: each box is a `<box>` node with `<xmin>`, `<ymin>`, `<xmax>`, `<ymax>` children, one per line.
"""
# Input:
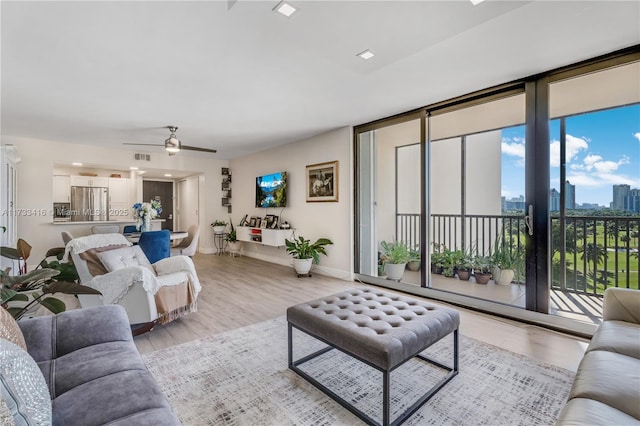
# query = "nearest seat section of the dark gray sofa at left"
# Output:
<box><xmin>53</xmin><ymin>370</ymin><xmax>180</xmax><ymax>426</ymax></box>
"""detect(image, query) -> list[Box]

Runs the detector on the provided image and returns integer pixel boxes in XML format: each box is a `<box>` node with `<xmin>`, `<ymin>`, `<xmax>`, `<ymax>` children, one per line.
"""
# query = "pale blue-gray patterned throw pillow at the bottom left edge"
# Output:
<box><xmin>0</xmin><ymin>339</ymin><xmax>51</xmax><ymax>426</ymax></box>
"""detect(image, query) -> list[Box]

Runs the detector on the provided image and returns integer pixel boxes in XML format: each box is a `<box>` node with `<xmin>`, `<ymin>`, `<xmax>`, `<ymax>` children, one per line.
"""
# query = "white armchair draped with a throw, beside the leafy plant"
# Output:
<box><xmin>65</xmin><ymin>233</ymin><xmax>201</xmax><ymax>324</ymax></box>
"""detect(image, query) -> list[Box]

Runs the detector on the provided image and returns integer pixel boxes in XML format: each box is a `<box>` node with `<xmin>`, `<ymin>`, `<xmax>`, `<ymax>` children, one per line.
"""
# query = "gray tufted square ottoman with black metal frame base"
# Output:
<box><xmin>287</xmin><ymin>289</ymin><xmax>460</xmax><ymax>426</ymax></box>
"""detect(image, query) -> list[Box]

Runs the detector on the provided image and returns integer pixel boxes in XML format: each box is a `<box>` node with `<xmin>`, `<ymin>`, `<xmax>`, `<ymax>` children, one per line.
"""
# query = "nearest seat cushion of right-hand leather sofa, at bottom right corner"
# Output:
<box><xmin>558</xmin><ymin>398</ymin><xmax>638</xmax><ymax>426</ymax></box>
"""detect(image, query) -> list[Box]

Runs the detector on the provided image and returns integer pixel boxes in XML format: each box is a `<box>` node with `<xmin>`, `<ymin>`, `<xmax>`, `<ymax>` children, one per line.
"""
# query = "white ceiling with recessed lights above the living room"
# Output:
<box><xmin>0</xmin><ymin>0</ymin><xmax>640</xmax><ymax>159</ymax></box>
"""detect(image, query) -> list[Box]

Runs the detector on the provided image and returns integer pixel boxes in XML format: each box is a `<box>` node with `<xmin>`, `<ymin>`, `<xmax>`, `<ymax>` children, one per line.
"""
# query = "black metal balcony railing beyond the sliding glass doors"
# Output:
<box><xmin>396</xmin><ymin>214</ymin><xmax>640</xmax><ymax>296</ymax></box>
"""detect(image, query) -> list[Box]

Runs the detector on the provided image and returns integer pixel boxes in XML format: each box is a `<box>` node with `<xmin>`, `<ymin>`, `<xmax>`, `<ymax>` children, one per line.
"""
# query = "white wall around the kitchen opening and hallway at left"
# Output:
<box><xmin>2</xmin><ymin>137</ymin><xmax>228</xmax><ymax>267</ymax></box>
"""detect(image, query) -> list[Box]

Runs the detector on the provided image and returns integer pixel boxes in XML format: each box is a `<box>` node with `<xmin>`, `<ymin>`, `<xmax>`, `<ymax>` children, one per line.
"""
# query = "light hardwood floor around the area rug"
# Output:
<box><xmin>135</xmin><ymin>254</ymin><xmax>588</xmax><ymax>371</ymax></box>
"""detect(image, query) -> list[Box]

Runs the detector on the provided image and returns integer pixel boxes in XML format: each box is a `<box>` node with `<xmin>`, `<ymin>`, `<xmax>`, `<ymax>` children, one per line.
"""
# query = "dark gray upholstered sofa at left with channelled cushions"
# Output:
<box><xmin>18</xmin><ymin>305</ymin><xmax>180</xmax><ymax>426</ymax></box>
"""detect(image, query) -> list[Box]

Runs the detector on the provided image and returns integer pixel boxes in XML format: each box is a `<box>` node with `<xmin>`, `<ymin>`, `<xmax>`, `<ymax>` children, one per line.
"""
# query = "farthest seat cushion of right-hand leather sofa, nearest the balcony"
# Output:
<box><xmin>587</xmin><ymin>321</ymin><xmax>640</xmax><ymax>359</ymax></box>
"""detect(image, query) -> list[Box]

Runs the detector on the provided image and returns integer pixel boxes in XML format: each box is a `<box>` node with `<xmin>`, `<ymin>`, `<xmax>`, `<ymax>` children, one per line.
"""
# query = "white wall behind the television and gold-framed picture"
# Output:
<box><xmin>229</xmin><ymin>127</ymin><xmax>353</xmax><ymax>279</ymax></box>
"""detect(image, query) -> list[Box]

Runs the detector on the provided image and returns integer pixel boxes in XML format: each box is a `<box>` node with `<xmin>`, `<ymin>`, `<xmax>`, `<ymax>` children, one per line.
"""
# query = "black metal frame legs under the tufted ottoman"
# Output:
<box><xmin>288</xmin><ymin>322</ymin><xmax>458</xmax><ymax>426</ymax></box>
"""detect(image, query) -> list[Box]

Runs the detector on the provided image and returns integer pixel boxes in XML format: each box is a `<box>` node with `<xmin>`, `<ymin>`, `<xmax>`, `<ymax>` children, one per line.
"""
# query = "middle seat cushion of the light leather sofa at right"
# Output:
<box><xmin>569</xmin><ymin>351</ymin><xmax>640</xmax><ymax>419</ymax></box>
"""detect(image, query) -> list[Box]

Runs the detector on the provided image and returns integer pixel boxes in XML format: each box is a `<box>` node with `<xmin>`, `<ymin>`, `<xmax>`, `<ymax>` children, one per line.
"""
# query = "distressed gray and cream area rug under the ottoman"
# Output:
<box><xmin>144</xmin><ymin>317</ymin><xmax>574</xmax><ymax>426</ymax></box>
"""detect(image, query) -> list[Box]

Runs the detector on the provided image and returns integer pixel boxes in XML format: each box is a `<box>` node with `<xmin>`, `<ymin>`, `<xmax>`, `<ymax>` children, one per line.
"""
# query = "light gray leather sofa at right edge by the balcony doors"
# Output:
<box><xmin>557</xmin><ymin>288</ymin><xmax>640</xmax><ymax>426</ymax></box>
